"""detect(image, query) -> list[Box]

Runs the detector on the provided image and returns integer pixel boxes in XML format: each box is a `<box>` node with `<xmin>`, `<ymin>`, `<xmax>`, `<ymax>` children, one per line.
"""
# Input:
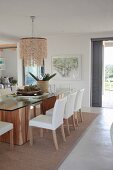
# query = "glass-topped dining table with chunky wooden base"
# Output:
<box><xmin>0</xmin><ymin>93</ymin><xmax>58</xmax><ymax>145</ymax></box>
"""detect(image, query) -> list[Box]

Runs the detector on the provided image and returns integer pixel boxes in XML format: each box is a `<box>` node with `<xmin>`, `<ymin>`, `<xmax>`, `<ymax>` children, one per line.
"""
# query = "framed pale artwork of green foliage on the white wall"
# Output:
<box><xmin>52</xmin><ymin>54</ymin><xmax>81</xmax><ymax>80</ymax></box>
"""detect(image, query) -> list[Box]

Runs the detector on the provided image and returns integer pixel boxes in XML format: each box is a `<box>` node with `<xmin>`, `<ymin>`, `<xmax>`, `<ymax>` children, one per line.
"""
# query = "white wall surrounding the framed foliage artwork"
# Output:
<box><xmin>45</xmin><ymin>32</ymin><xmax>113</xmax><ymax>107</ymax></box>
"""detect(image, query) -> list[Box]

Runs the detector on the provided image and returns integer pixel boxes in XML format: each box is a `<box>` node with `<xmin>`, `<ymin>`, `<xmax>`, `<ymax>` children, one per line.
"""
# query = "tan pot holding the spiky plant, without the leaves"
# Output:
<box><xmin>38</xmin><ymin>80</ymin><xmax>49</xmax><ymax>93</ymax></box>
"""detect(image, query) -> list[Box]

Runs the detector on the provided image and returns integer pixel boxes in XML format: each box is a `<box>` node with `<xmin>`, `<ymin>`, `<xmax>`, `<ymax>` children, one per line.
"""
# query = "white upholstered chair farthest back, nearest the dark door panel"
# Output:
<box><xmin>74</xmin><ymin>89</ymin><xmax>84</xmax><ymax>124</ymax></box>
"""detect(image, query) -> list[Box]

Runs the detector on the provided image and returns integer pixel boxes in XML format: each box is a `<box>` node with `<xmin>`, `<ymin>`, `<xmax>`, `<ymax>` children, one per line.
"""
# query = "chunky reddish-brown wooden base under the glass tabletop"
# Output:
<box><xmin>0</xmin><ymin>96</ymin><xmax>56</xmax><ymax>145</ymax></box>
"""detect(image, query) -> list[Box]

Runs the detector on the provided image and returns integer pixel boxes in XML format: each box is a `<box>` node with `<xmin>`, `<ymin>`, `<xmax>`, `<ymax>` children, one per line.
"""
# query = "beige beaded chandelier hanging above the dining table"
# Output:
<box><xmin>20</xmin><ymin>16</ymin><xmax>47</xmax><ymax>66</ymax></box>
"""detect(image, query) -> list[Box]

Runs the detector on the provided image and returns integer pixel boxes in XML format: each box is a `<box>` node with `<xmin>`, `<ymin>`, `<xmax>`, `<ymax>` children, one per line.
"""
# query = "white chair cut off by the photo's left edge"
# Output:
<box><xmin>0</xmin><ymin>121</ymin><xmax>13</xmax><ymax>149</ymax></box>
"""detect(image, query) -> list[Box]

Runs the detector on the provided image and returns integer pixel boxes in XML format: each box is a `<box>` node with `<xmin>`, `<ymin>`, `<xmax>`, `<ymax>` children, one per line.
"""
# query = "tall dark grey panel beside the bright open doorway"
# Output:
<box><xmin>91</xmin><ymin>40</ymin><xmax>103</xmax><ymax>107</ymax></box>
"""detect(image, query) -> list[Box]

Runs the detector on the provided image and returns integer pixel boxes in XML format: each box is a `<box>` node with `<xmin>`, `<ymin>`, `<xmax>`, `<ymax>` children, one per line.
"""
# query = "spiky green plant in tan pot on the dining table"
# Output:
<box><xmin>29</xmin><ymin>72</ymin><xmax>56</xmax><ymax>92</ymax></box>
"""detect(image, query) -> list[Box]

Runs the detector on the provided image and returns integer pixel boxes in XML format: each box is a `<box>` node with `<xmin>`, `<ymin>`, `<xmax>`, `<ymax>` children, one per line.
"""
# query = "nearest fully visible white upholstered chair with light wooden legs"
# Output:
<box><xmin>29</xmin><ymin>97</ymin><xmax>67</xmax><ymax>150</ymax></box>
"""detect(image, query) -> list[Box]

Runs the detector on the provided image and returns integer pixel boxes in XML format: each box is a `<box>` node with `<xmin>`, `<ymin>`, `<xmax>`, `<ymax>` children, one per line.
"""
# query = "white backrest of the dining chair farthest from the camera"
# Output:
<box><xmin>74</xmin><ymin>89</ymin><xmax>84</xmax><ymax>111</ymax></box>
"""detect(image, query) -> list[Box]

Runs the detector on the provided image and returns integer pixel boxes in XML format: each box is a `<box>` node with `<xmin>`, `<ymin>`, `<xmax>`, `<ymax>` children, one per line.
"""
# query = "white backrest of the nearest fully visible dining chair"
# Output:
<box><xmin>52</xmin><ymin>97</ymin><xmax>67</xmax><ymax>129</ymax></box>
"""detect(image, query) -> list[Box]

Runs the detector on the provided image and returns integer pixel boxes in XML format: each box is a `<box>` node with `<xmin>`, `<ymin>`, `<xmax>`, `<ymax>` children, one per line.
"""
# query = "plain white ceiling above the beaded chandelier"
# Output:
<box><xmin>0</xmin><ymin>0</ymin><xmax>113</xmax><ymax>40</ymax></box>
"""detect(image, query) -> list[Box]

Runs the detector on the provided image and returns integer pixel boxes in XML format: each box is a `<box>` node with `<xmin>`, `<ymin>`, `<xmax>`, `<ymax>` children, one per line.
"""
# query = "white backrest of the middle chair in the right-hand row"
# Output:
<box><xmin>64</xmin><ymin>92</ymin><xmax>77</xmax><ymax>119</ymax></box>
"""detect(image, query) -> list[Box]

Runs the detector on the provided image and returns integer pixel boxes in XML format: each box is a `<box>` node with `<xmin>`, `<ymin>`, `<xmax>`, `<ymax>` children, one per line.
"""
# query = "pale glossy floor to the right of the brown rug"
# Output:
<box><xmin>59</xmin><ymin>108</ymin><xmax>113</xmax><ymax>170</ymax></box>
